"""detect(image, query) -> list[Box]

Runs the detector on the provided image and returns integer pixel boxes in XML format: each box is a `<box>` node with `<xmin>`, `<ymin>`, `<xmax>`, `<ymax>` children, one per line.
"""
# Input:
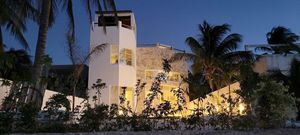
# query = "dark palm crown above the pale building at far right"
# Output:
<box><xmin>255</xmin><ymin>26</ymin><xmax>299</xmax><ymax>54</ymax></box>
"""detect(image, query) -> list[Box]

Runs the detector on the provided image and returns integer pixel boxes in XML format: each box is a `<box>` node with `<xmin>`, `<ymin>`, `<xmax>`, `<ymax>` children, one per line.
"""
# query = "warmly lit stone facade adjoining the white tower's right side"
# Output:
<box><xmin>136</xmin><ymin>43</ymin><xmax>189</xmax><ymax>112</ymax></box>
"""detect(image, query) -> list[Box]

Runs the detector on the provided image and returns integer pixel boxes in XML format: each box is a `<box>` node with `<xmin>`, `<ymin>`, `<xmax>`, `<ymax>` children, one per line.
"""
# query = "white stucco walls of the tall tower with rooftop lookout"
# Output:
<box><xmin>88</xmin><ymin>13</ymin><xmax>136</xmax><ymax>104</ymax></box>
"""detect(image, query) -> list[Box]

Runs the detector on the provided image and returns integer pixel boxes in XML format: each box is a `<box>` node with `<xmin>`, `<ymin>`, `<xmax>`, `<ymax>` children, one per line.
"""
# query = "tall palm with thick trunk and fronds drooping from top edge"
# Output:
<box><xmin>33</xmin><ymin>0</ymin><xmax>116</xmax><ymax>106</ymax></box>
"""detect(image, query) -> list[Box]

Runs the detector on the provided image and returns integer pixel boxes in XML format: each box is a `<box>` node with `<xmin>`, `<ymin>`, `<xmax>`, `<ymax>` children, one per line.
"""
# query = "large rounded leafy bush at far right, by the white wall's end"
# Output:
<box><xmin>252</xmin><ymin>77</ymin><xmax>297</xmax><ymax>128</ymax></box>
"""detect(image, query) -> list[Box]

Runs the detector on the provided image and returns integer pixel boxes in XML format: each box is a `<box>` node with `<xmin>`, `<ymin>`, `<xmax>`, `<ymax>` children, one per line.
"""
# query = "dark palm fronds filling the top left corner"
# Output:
<box><xmin>0</xmin><ymin>0</ymin><xmax>38</xmax><ymax>54</ymax></box>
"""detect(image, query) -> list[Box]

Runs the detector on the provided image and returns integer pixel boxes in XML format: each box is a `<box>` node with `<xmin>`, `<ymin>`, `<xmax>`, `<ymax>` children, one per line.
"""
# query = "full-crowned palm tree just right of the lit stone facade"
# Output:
<box><xmin>171</xmin><ymin>21</ymin><xmax>253</xmax><ymax>90</ymax></box>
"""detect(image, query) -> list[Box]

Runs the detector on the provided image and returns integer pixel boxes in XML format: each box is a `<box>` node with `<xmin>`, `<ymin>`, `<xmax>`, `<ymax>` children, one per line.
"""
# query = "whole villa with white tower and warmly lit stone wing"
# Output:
<box><xmin>88</xmin><ymin>11</ymin><xmax>188</xmax><ymax>110</ymax></box>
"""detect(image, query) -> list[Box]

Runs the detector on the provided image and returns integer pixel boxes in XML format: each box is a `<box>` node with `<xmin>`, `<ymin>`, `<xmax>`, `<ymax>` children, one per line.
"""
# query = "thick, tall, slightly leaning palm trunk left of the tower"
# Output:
<box><xmin>32</xmin><ymin>0</ymin><xmax>51</xmax><ymax>106</ymax></box>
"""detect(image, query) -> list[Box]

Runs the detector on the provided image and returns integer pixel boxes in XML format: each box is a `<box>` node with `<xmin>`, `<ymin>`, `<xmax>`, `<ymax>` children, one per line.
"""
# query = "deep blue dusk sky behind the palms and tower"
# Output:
<box><xmin>4</xmin><ymin>0</ymin><xmax>300</xmax><ymax>64</ymax></box>
